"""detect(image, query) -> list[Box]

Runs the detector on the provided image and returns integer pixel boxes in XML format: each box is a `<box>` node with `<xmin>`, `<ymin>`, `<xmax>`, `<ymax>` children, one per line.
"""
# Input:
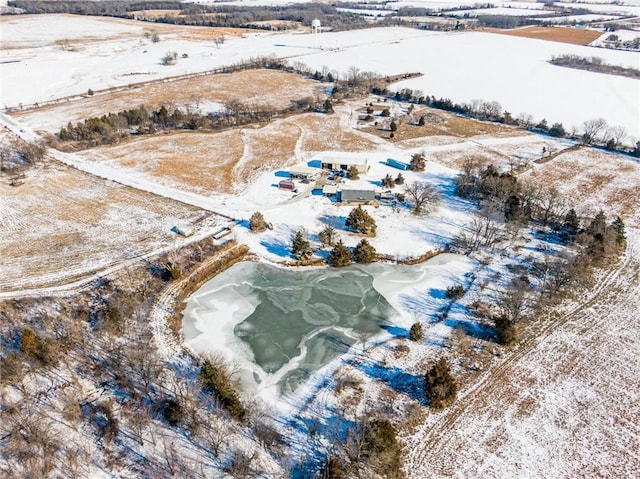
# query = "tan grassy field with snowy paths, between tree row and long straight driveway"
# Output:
<box><xmin>79</xmin><ymin>113</ymin><xmax>376</xmax><ymax>194</ymax></box>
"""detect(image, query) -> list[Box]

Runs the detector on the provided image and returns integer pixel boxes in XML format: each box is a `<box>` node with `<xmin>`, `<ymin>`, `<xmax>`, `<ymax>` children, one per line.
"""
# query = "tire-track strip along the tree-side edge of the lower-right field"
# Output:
<box><xmin>406</xmin><ymin>250</ymin><xmax>640</xmax><ymax>471</ymax></box>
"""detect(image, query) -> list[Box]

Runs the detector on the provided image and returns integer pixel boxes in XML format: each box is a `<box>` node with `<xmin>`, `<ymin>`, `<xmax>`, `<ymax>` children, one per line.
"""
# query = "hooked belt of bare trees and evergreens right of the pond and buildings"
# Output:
<box><xmin>452</xmin><ymin>160</ymin><xmax>626</xmax><ymax>344</ymax></box>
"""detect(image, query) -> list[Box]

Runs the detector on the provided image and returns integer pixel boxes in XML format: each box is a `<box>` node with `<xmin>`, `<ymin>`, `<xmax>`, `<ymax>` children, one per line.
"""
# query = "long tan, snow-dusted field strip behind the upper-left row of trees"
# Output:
<box><xmin>12</xmin><ymin>70</ymin><xmax>321</xmax><ymax>133</ymax></box>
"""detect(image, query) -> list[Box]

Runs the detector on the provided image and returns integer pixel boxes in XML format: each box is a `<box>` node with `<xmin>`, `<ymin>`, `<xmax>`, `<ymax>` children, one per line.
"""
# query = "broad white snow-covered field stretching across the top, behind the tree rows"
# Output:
<box><xmin>0</xmin><ymin>16</ymin><xmax>640</xmax><ymax>137</ymax></box>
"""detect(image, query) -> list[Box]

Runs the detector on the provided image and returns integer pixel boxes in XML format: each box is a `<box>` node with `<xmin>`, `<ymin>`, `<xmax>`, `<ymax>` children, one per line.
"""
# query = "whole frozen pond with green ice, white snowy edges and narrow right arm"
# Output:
<box><xmin>183</xmin><ymin>254</ymin><xmax>470</xmax><ymax>402</ymax></box>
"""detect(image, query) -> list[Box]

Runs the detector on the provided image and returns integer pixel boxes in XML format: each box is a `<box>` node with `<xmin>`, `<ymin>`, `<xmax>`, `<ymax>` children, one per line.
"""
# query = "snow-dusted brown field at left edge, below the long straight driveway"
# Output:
<box><xmin>0</xmin><ymin>161</ymin><xmax>220</xmax><ymax>292</ymax></box>
